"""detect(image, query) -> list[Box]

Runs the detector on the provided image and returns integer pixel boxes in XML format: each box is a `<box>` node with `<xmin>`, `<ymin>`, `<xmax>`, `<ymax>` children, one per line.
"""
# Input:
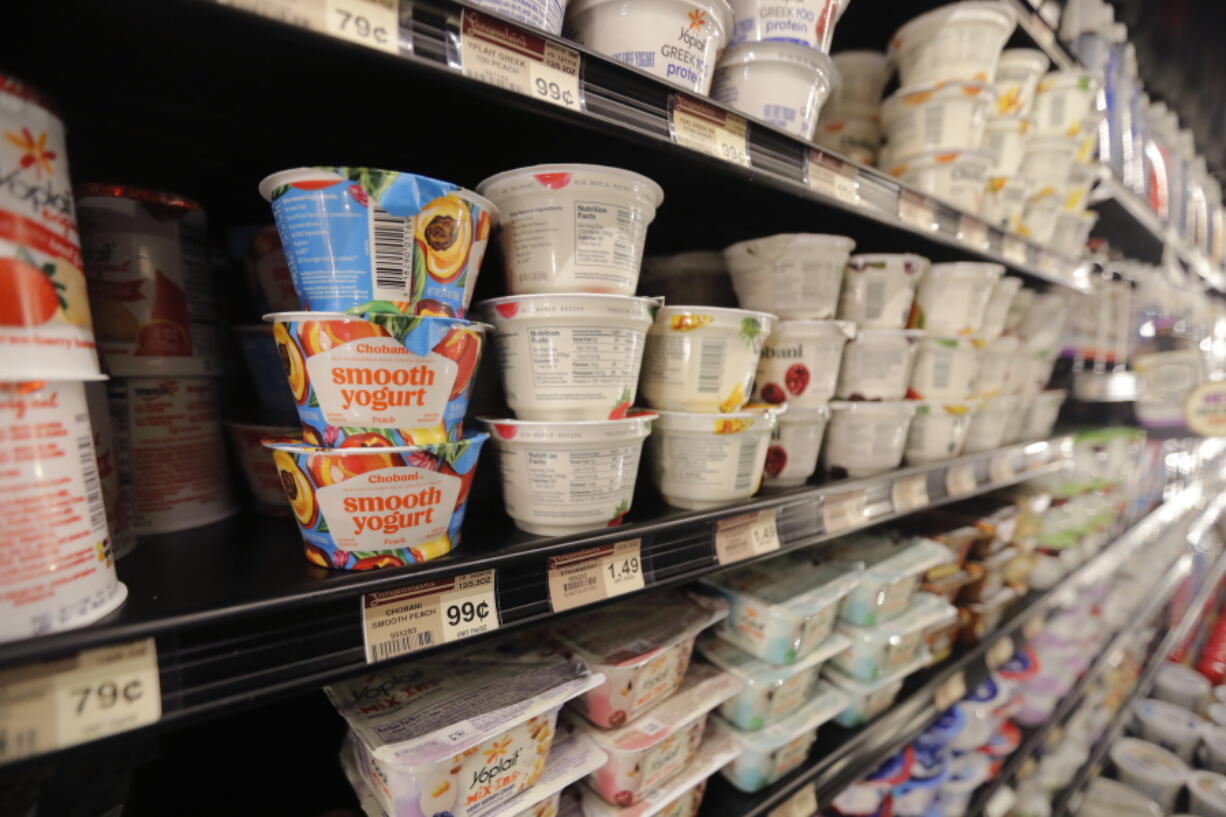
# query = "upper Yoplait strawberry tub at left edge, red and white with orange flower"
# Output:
<box><xmin>0</xmin><ymin>74</ymin><xmax>98</xmax><ymax>380</ymax></box>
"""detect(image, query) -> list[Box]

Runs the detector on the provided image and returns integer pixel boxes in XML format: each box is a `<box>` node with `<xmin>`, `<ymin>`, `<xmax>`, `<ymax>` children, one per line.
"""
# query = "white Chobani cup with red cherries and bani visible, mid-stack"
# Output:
<box><xmin>754</xmin><ymin>320</ymin><xmax>856</xmax><ymax>407</ymax></box>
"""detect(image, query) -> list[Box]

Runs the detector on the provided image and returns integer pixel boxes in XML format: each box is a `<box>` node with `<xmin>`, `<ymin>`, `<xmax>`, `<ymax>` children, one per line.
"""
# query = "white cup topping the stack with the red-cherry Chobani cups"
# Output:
<box><xmin>723</xmin><ymin>233</ymin><xmax>856</xmax><ymax>320</ymax></box>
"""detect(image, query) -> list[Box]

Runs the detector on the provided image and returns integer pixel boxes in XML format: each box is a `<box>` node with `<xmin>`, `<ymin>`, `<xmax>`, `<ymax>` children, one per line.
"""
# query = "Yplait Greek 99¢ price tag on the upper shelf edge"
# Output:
<box><xmin>460</xmin><ymin>9</ymin><xmax>584</xmax><ymax>110</ymax></box>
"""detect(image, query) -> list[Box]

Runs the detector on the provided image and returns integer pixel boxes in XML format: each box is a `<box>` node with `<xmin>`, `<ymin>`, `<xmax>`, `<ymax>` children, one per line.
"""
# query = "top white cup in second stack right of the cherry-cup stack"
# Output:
<box><xmin>907</xmin><ymin>261</ymin><xmax>1004</xmax><ymax>337</ymax></box>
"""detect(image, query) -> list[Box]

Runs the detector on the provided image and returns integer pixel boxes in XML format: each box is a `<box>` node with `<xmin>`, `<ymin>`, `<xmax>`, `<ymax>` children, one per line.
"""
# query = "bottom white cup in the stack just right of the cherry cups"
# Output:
<box><xmin>823</xmin><ymin>400</ymin><xmax>916</xmax><ymax>477</ymax></box>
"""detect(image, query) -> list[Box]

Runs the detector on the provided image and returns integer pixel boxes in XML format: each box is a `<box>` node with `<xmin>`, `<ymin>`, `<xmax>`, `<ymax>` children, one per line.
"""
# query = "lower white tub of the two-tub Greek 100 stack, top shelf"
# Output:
<box><xmin>711</xmin><ymin>42</ymin><xmax>837</xmax><ymax>140</ymax></box>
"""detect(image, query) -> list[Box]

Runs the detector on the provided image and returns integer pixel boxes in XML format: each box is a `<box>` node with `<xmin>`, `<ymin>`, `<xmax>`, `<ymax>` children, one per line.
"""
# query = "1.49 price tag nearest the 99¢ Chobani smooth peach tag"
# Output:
<box><xmin>548</xmin><ymin>539</ymin><xmax>644</xmax><ymax>612</ymax></box>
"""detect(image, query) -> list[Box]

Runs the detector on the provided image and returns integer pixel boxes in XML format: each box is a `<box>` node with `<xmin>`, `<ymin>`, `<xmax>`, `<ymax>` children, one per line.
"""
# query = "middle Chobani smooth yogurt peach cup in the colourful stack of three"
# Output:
<box><xmin>267</xmin><ymin>312</ymin><xmax>487</xmax><ymax>448</ymax></box>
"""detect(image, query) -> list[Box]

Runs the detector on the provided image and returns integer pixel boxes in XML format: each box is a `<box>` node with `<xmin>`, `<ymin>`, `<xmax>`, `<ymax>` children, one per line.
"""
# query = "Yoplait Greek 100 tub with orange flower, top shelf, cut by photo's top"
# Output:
<box><xmin>565</xmin><ymin>0</ymin><xmax>732</xmax><ymax>96</ymax></box>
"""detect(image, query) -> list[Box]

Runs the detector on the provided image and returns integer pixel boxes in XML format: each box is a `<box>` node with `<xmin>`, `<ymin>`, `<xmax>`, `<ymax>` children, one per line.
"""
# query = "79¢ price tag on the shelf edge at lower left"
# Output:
<box><xmin>0</xmin><ymin>638</ymin><xmax>162</xmax><ymax>762</ymax></box>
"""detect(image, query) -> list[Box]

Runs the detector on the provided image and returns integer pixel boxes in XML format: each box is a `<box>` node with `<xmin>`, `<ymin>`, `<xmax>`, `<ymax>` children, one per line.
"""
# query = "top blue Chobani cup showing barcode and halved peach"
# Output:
<box><xmin>260</xmin><ymin>167</ymin><xmax>498</xmax><ymax>318</ymax></box>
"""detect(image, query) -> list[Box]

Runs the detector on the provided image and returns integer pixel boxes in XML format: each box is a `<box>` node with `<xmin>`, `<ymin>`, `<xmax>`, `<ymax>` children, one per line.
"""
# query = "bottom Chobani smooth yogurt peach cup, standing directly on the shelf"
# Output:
<box><xmin>265</xmin><ymin>432</ymin><xmax>489</xmax><ymax>570</ymax></box>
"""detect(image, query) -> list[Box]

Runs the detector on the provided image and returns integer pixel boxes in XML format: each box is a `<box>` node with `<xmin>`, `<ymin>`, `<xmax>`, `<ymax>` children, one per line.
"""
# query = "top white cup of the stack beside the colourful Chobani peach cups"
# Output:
<box><xmin>477</xmin><ymin>164</ymin><xmax>662</xmax><ymax>296</ymax></box>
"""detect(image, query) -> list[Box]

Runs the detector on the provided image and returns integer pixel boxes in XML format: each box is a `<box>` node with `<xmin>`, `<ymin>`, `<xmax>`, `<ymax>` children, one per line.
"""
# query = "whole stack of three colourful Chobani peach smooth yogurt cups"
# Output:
<box><xmin>260</xmin><ymin>167</ymin><xmax>498</xmax><ymax>570</ymax></box>
